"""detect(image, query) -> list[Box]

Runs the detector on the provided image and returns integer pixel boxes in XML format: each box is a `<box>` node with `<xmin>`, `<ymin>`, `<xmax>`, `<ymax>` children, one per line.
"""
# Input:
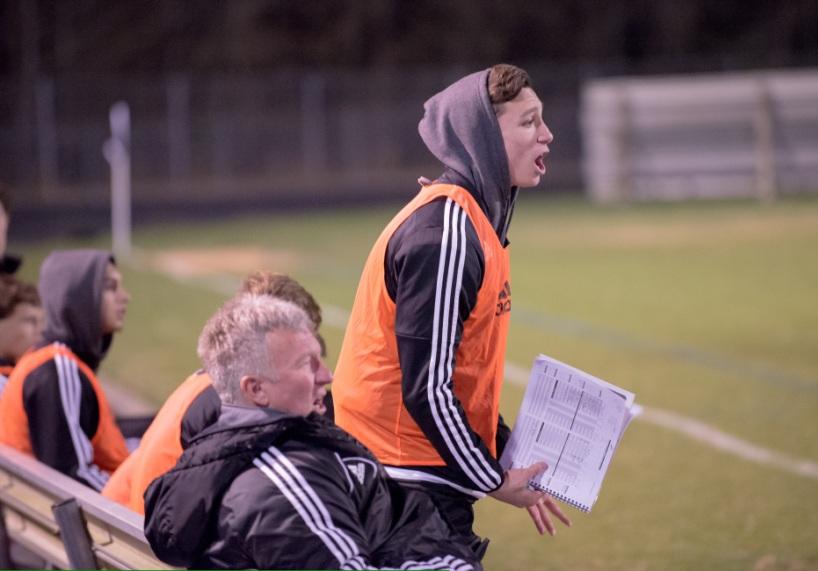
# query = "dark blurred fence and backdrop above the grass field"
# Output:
<box><xmin>0</xmin><ymin>0</ymin><xmax>818</xmax><ymax>239</ymax></box>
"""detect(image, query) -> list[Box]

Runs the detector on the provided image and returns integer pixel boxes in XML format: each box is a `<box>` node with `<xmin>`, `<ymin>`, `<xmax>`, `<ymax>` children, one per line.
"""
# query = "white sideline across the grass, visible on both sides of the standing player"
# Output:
<box><xmin>134</xmin><ymin>264</ymin><xmax>818</xmax><ymax>480</ymax></box>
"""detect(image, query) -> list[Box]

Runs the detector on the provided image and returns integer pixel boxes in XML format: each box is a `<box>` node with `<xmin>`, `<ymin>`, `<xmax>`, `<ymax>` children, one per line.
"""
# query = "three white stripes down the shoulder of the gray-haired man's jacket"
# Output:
<box><xmin>253</xmin><ymin>446</ymin><xmax>366</xmax><ymax>569</ymax></box>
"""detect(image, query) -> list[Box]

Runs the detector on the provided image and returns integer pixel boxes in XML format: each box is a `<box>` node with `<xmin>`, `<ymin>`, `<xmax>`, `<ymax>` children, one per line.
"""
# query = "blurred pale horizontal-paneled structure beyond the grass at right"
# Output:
<box><xmin>581</xmin><ymin>71</ymin><xmax>818</xmax><ymax>202</ymax></box>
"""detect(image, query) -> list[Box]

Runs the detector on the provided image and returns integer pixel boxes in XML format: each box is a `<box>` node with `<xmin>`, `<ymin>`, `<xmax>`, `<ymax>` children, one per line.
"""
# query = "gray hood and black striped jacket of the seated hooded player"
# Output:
<box><xmin>7</xmin><ymin>250</ymin><xmax>127</xmax><ymax>490</ymax></box>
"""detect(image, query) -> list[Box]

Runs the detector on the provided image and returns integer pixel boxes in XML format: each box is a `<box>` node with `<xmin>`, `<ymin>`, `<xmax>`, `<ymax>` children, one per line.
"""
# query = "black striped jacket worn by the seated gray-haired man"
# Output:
<box><xmin>145</xmin><ymin>405</ymin><xmax>482</xmax><ymax>571</ymax></box>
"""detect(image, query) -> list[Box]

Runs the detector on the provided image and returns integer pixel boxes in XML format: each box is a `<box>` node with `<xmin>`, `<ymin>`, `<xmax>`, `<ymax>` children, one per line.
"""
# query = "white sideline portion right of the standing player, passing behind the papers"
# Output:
<box><xmin>506</xmin><ymin>363</ymin><xmax>818</xmax><ymax>480</ymax></box>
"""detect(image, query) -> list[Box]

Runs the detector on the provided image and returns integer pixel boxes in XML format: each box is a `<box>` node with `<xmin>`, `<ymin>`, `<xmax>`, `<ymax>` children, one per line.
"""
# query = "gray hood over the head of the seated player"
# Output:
<box><xmin>38</xmin><ymin>250</ymin><xmax>115</xmax><ymax>370</ymax></box>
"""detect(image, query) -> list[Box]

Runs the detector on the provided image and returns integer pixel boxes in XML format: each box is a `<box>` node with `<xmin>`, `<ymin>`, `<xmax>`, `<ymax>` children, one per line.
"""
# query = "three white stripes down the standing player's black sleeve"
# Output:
<box><xmin>426</xmin><ymin>199</ymin><xmax>502</xmax><ymax>491</ymax></box>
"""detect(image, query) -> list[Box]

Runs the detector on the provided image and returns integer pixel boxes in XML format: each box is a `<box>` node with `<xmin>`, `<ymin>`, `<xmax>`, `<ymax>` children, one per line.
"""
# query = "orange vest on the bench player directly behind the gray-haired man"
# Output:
<box><xmin>102</xmin><ymin>372</ymin><xmax>212</xmax><ymax>514</ymax></box>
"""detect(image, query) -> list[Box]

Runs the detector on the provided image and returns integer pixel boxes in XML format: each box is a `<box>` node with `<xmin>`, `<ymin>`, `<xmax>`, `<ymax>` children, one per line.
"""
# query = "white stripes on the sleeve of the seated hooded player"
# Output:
<box><xmin>54</xmin><ymin>346</ymin><xmax>108</xmax><ymax>490</ymax></box>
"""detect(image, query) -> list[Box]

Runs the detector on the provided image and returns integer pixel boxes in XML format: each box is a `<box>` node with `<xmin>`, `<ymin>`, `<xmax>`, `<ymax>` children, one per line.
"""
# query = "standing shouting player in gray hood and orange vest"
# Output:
<box><xmin>333</xmin><ymin>64</ymin><xmax>569</xmax><ymax>556</ymax></box>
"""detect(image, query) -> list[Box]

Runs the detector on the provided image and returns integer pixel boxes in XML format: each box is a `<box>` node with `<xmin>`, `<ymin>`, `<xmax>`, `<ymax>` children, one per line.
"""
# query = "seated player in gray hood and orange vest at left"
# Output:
<box><xmin>0</xmin><ymin>250</ymin><xmax>130</xmax><ymax>490</ymax></box>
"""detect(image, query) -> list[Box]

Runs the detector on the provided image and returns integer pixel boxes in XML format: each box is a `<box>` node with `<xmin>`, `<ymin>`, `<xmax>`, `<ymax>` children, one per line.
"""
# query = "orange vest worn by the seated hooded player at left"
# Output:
<box><xmin>0</xmin><ymin>343</ymin><xmax>128</xmax><ymax>472</ymax></box>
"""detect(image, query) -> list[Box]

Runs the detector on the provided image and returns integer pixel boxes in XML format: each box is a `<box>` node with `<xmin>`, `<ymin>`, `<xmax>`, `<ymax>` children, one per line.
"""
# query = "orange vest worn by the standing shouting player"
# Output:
<box><xmin>332</xmin><ymin>184</ymin><xmax>511</xmax><ymax>466</ymax></box>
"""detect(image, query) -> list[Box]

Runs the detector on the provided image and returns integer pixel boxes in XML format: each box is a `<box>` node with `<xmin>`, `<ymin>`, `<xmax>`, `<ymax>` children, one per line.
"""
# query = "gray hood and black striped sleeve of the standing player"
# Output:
<box><xmin>370</xmin><ymin>70</ymin><xmax>516</xmax><ymax>500</ymax></box>
